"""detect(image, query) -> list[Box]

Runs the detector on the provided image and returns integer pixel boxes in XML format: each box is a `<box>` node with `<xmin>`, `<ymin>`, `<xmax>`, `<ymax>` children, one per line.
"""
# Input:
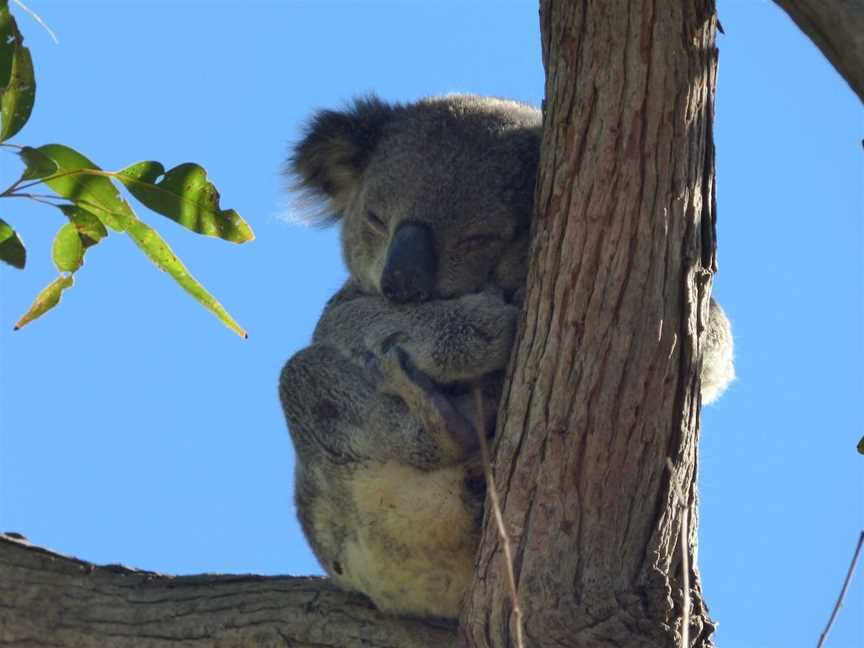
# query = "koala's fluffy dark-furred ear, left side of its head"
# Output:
<box><xmin>286</xmin><ymin>96</ymin><xmax>398</xmax><ymax>223</ymax></box>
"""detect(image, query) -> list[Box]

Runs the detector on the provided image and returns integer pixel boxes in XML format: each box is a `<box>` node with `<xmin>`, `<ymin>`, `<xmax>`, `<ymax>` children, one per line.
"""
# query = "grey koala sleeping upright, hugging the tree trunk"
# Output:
<box><xmin>279</xmin><ymin>95</ymin><xmax>734</xmax><ymax>618</ymax></box>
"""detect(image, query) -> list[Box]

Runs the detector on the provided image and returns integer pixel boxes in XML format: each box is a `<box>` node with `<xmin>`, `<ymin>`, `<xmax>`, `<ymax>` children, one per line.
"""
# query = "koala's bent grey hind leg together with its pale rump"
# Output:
<box><xmin>279</xmin><ymin>345</ymin><xmax>483</xmax><ymax>617</ymax></box>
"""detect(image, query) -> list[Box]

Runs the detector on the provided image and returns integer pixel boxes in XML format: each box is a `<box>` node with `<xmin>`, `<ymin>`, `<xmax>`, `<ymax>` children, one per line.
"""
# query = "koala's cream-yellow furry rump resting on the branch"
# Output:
<box><xmin>316</xmin><ymin>462</ymin><xmax>479</xmax><ymax>618</ymax></box>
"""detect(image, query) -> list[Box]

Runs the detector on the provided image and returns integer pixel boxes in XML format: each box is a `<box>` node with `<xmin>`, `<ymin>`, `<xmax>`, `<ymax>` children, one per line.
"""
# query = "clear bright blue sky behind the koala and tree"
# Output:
<box><xmin>0</xmin><ymin>0</ymin><xmax>864</xmax><ymax>648</ymax></box>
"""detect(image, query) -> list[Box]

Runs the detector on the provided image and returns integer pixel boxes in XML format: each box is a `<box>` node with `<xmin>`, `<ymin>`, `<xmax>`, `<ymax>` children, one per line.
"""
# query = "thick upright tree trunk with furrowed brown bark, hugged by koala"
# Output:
<box><xmin>460</xmin><ymin>0</ymin><xmax>717</xmax><ymax>648</ymax></box>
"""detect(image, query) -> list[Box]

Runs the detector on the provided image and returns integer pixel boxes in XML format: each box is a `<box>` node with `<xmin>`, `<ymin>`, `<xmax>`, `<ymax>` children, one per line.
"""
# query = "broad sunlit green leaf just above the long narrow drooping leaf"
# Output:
<box><xmin>36</xmin><ymin>144</ymin><xmax>138</xmax><ymax>232</ymax></box>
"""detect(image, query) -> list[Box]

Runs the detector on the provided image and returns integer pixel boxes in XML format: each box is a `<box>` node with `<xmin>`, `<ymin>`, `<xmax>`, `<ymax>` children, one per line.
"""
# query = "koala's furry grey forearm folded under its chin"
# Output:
<box><xmin>314</xmin><ymin>282</ymin><xmax>519</xmax><ymax>384</ymax></box>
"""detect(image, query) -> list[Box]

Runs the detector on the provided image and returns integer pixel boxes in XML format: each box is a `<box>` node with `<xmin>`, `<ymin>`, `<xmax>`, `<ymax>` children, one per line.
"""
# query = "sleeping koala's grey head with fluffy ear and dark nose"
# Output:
<box><xmin>288</xmin><ymin>95</ymin><xmax>540</xmax><ymax>302</ymax></box>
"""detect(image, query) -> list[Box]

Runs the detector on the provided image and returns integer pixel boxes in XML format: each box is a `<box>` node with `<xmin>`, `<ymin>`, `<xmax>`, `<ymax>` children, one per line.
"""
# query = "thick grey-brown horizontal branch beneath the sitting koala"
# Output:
<box><xmin>0</xmin><ymin>534</ymin><xmax>455</xmax><ymax>648</ymax></box>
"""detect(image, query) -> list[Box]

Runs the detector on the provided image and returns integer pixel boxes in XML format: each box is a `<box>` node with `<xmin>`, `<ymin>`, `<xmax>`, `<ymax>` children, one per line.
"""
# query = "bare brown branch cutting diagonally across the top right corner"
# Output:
<box><xmin>774</xmin><ymin>0</ymin><xmax>864</xmax><ymax>101</ymax></box>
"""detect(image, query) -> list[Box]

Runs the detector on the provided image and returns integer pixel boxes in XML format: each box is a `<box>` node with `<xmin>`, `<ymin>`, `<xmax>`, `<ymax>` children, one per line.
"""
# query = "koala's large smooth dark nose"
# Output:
<box><xmin>381</xmin><ymin>221</ymin><xmax>438</xmax><ymax>304</ymax></box>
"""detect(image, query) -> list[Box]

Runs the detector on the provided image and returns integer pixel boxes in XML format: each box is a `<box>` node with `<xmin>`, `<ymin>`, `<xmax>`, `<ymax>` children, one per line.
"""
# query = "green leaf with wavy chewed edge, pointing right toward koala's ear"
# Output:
<box><xmin>114</xmin><ymin>162</ymin><xmax>255</xmax><ymax>243</ymax></box>
